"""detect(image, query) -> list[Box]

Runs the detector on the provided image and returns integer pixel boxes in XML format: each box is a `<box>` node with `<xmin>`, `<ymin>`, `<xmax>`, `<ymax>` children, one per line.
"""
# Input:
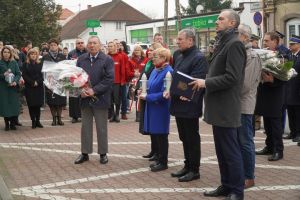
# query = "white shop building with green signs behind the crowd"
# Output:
<box><xmin>126</xmin><ymin>2</ymin><xmax>263</xmax><ymax>47</ymax></box>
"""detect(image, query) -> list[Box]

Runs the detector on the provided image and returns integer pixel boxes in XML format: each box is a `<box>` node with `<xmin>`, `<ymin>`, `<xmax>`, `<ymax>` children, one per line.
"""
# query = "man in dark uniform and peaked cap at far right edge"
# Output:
<box><xmin>286</xmin><ymin>35</ymin><xmax>300</xmax><ymax>142</ymax></box>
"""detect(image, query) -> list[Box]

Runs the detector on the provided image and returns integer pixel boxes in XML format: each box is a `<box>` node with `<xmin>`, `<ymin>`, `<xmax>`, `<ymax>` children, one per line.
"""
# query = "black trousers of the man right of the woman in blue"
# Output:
<box><xmin>175</xmin><ymin>117</ymin><xmax>201</xmax><ymax>173</ymax></box>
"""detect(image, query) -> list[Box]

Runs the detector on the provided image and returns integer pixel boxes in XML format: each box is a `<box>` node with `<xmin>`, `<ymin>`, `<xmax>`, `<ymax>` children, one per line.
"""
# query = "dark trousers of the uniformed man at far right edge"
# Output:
<box><xmin>287</xmin><ymin>105</ymin><xmax>300</xmax><ymax>138</ymax></box>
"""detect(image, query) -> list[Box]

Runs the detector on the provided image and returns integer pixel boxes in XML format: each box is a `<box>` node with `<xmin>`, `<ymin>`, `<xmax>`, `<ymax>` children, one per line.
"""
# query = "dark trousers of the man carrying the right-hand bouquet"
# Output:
<box><xmin>264</xmin><ymin>117</ymin><xmax>283</xmax><ymax>152</ymax></box>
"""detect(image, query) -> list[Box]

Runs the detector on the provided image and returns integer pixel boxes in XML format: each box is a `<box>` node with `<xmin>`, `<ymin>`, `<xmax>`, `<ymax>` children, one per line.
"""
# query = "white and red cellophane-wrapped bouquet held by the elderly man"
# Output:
<box><xmin>42</xmin><ymin>60</ymin><xmax>90</xmax><ymax>97</ymax></box>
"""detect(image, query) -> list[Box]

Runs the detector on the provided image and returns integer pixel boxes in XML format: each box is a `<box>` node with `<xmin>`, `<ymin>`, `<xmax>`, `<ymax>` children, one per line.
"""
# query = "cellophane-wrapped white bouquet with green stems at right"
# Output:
<box><xmin>254</xmin><ymin>49</ymin><xmax>297</xmax><ymax>81</ymax></box>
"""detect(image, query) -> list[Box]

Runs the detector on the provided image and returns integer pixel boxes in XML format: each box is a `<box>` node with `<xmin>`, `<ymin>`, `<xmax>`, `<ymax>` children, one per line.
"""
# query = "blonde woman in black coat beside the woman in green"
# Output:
<box><xmin>22</xmin><ymin>48</ymin><xmax>44</xmax><ymax>129</ymax></box>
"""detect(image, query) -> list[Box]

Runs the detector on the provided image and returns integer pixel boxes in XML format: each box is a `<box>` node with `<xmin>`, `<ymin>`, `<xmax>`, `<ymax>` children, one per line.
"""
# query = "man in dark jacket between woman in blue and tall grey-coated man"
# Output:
<box><xmin>170</xmin><ymin>29</ymin><xmax>207</xmax><ymax>182</ymax></box>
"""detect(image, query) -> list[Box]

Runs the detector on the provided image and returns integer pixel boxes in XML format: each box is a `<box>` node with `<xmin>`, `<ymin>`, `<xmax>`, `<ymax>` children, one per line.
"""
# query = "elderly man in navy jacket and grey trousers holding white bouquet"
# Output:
<box><xmin>75</xmin><ymin>36</ymin><xmax>114</xmax><ymax>164</ymax></box>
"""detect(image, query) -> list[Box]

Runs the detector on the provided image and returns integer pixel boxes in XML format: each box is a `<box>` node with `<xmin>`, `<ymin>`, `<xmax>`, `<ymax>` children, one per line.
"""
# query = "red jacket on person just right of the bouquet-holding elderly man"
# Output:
<box><xmin>108</xmin><ymin>53</ymin><xmax>126</xmax><ymax>85</ymax></box>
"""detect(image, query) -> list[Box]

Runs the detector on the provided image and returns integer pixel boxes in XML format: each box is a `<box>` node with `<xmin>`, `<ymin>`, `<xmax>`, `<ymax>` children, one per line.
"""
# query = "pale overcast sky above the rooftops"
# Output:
<box><xmin>55</xmin><ymin>0</ymin><xmax>246</xmax><ymax>18</ymax></box>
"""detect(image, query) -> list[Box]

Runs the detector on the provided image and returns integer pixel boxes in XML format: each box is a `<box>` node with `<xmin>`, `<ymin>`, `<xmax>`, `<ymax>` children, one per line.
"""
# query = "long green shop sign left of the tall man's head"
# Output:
<box><xmin>176</xmin><ymin>15</ymin><xmax>219</xmax><ymax>29</ymax></box>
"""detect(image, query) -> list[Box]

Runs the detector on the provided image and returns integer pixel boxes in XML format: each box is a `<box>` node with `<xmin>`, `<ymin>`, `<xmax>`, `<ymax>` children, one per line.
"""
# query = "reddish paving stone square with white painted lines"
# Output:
<box><xmin>0</xmin><ymin>108</ymin><xmax>300</xmax><ymax>200</ymax></box>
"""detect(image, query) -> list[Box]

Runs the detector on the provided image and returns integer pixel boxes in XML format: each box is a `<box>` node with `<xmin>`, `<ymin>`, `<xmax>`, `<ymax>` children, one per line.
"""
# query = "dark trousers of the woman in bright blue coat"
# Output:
<box><xmin>151</xmin><ymin>134</ymin><xmax>169</xmax><ymax>165</ymax></box>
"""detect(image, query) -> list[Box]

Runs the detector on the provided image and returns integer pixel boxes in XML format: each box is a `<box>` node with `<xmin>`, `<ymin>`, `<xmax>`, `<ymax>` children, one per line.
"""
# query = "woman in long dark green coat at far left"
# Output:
<box><xmin>0</xmin><ymin>46</ymin><xmax>21</xmax><ymax>131</ymax></box>
